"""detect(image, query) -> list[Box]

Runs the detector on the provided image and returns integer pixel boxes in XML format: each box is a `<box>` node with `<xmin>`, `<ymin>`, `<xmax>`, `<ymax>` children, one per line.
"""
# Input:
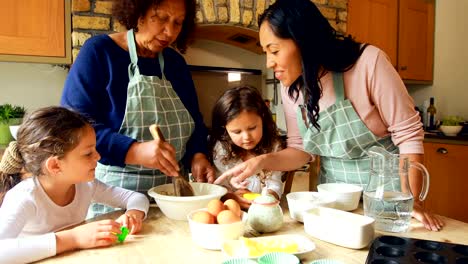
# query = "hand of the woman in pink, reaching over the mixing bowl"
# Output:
<box><xmin>214</xmin><ymin>155</ymin><xmax>265</xmax><ymax>189</ymax></box>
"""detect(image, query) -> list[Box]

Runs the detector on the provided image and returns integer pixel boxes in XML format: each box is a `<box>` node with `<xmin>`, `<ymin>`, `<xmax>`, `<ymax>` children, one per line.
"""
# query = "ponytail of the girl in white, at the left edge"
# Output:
<box><xmin>0</xmin><ymin>141</ymin><xmax>24</xmax><ymax>205</ymax></box>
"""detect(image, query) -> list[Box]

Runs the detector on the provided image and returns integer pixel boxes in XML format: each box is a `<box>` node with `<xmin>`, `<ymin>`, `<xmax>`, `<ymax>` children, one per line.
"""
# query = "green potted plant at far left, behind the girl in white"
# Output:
<box><xmin>0</xmin><ymin>104</ymin><xmax>26</xmax><ymax>145</ymax></box>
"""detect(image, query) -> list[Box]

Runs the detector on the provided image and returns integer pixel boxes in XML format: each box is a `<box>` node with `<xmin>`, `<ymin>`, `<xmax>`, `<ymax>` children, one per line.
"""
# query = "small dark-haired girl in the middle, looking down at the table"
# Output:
<box><xmin>209</xmin><ymin>86</ymin><xmax>284</xmax><ymax>209</ymax></box>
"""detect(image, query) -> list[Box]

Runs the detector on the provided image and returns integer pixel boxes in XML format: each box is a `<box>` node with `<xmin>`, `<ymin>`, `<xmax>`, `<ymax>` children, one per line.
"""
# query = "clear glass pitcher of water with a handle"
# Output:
<box><xmin>363</xmin><ymin>147</ymin><xmax>429</xmax><ymax>232</ymax></box>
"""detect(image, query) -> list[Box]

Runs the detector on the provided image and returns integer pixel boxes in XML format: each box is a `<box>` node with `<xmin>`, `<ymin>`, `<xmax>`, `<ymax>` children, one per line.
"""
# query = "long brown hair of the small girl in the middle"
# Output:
<box><xmin>209</xmin><ymin>86</ymin><xmax>280</xmax><ymax>162</ymax></box>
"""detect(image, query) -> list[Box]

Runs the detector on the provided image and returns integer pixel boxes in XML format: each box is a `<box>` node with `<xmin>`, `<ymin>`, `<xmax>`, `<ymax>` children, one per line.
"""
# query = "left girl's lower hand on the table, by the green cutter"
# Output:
<box><xmin>71</xmin><ymin>220</ymin><xmax>120</xmax><ymax>248</ymax></box>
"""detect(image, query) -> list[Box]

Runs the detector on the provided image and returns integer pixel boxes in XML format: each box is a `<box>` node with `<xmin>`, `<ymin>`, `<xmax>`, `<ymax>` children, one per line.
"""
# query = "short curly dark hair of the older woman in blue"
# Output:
<box><xmin>112</xmin><ymin>0</ymin><xmax>196</xmax><ymax>53</ymax></box>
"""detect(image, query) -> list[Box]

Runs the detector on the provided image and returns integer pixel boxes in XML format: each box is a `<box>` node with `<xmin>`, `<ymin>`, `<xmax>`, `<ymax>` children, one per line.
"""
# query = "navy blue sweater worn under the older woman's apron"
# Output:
<box><xmin>61</xmin><ymin>35</ymin><xmax>208</xmax><ymax>168</ymax></box>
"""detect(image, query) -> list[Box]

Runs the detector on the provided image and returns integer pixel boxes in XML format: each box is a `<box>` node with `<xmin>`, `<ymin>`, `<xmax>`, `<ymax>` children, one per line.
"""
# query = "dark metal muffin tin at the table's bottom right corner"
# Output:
<box><xmin>366</xmin><ymin>236</ymin><xmax>468</xmax><ymax>264</ymax></box>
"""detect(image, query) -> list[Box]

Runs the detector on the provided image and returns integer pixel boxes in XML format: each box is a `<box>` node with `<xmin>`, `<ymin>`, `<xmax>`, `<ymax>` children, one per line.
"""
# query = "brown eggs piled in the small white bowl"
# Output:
<box><xmin>192</xmin><ymin>199</ymin><xmax>242</xmax><ymax>224</ymax></box>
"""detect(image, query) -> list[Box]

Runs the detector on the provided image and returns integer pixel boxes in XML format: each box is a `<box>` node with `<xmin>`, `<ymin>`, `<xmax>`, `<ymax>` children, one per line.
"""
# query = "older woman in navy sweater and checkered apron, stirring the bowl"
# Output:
<box><xmin>61</xmin><ymin>0</ymin><xmax>214</xmax><ymax>216</ymax></box>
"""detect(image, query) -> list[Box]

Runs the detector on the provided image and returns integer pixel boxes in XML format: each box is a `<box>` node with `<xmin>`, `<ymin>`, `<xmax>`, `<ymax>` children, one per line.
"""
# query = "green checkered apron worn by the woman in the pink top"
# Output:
<box><xmin>296</xmin><ymin>72</ymin><xmax>399</xmax><ymax>189</ymax></box>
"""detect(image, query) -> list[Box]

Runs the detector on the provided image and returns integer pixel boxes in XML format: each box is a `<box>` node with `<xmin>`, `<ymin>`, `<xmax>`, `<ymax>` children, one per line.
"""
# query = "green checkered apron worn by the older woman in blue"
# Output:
<box><xmin>88</xmin><ymin>30</ymin><xmax>195</xmax><ymax>217</ymax></box>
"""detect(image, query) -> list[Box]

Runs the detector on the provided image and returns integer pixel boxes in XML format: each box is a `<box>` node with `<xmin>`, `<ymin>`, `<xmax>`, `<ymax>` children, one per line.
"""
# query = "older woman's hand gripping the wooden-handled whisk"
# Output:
<box><xmin>125</xmin><ymin>139</ymin><xmax>180</xmax><ymax>176</ymax></box>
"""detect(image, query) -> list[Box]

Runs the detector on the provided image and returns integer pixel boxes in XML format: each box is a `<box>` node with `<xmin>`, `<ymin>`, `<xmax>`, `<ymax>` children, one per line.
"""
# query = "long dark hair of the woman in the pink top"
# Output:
<box><xmin>258</xmin><ymin>0</ymin><xmax>365</xmax><ymax>129</ymax></box>
